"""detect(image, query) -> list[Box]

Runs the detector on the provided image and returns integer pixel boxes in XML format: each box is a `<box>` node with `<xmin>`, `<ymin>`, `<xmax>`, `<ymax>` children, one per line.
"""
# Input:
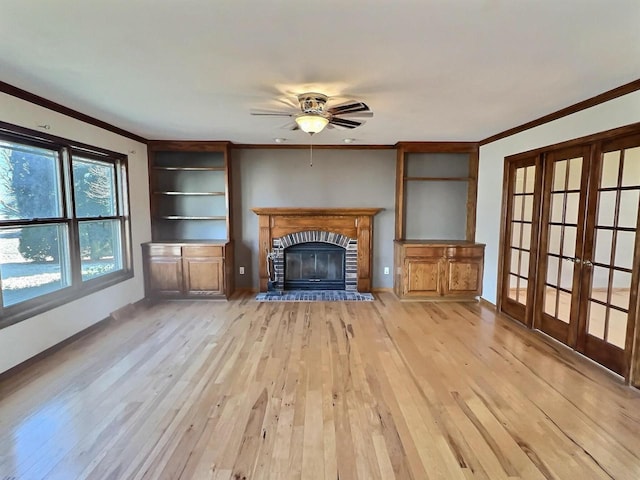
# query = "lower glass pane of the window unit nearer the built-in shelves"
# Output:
<box><xmin>78</xmin><ymin>220</ymin><xmax>123</xmax><ymax>280</ymax></box>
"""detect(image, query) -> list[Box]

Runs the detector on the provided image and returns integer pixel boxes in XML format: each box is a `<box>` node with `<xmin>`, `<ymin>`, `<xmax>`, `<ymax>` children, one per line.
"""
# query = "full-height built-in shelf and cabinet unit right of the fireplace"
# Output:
<box><xmin>394</xmin><ymin>142</ymin><xmax>484</xmax><ymax>300</ymax></box>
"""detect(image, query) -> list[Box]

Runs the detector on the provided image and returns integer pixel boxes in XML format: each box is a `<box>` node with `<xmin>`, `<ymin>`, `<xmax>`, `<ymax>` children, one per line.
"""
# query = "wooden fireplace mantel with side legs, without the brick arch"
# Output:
<box><xmin>252</xmin><ymin>207</ymin><xmax>384</xmax><ymax>292</ymax></box>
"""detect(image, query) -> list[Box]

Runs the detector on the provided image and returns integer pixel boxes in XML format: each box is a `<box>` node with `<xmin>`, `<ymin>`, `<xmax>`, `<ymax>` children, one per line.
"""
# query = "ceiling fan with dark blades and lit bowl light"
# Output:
<box><xmin>251</xmin><ymin>92</ymin><xmax>373</xmax><ymax>135</ymax></box>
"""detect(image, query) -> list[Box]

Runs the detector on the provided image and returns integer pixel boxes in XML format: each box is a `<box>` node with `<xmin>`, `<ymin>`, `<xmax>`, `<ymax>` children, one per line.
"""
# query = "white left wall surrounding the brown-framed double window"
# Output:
<box><xmin>0</xmin><ymin>94</ymin><xmax>151</xmax><ymax>373</ymax></box>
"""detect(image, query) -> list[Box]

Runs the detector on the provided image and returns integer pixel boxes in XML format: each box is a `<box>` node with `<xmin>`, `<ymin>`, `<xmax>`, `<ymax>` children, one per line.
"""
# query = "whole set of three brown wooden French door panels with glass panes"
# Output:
<box><xmin>500</xmin><ymin>135</ymin><xmax>640</xmax><ymax>377</ymax></box>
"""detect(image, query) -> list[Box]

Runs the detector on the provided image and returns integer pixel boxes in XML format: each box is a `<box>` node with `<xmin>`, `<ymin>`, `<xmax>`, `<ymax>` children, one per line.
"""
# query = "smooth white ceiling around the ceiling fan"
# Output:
<box><xmin>0</xmin><ymin>0</ymin><xmax>640</xmax><ymax>144</ymax></box>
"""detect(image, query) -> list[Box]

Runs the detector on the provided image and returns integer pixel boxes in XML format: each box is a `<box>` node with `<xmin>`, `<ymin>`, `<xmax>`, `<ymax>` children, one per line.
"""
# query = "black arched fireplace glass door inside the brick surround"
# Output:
<box><xmin>284</xmin><ymin>242</ymin><xmax>345</xmax><ymax>290</ymax></box>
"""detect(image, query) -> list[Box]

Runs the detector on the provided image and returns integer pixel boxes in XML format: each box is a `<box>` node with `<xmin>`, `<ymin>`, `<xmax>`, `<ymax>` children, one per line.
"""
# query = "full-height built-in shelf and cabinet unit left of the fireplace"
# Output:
<box><xmin>143</xmin><ymin>141</ymin><xmax>233</xmax><ymax>297</ymax></box>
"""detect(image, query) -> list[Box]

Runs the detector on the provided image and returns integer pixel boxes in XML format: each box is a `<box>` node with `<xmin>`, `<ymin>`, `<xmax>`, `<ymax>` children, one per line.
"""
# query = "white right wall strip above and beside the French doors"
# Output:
<box><xmin>476</xmin><ymin>91</ymin><xmax>640</xmax><ymax>303</ymax></box>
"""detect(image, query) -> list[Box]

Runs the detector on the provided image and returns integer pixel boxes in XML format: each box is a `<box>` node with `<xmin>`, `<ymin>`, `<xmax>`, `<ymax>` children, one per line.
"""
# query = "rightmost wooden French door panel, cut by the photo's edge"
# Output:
<box><xmin>577</xmin><ymin>136</ymin><xmax>640</xmax><ymax>377</ymax></box>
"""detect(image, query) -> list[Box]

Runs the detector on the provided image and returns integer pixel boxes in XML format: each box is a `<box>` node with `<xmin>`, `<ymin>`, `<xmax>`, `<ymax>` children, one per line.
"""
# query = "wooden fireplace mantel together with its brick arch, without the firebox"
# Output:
<box><xmin>253</xmin><ymin>208</ymin><xmax>383</xmax><ymax>293</ymax></box>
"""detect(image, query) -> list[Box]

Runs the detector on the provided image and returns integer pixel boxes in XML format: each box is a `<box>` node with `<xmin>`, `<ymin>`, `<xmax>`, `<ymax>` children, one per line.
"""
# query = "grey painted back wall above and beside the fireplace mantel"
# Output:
<box><xmin>232</xmin><ymin>149</ymin><xmax>396</xmax><ymax>289</ymax></box>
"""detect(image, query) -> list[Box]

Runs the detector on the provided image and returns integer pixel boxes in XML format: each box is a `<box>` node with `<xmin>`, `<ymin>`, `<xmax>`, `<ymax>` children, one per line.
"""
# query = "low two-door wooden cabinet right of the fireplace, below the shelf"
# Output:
<box><xmin>394</xmin><ymin>240</ymin><xmax>484</xmax><ymax>300</ymax></box>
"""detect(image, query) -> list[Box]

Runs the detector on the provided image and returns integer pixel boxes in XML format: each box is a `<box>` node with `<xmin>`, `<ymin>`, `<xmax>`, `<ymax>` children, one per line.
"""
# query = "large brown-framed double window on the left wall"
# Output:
<box><xmin>0</xmin><ymin>123</ymin><xmax>133</xmax><ymax>328</ymax></box>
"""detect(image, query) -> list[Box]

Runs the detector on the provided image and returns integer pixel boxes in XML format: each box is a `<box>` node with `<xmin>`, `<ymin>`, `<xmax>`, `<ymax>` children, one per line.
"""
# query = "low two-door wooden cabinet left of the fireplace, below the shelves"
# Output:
<box><xmin>142</xmin><ymin>242</ymin><xmax>233</xmax><ymax>298</ymax></box>
